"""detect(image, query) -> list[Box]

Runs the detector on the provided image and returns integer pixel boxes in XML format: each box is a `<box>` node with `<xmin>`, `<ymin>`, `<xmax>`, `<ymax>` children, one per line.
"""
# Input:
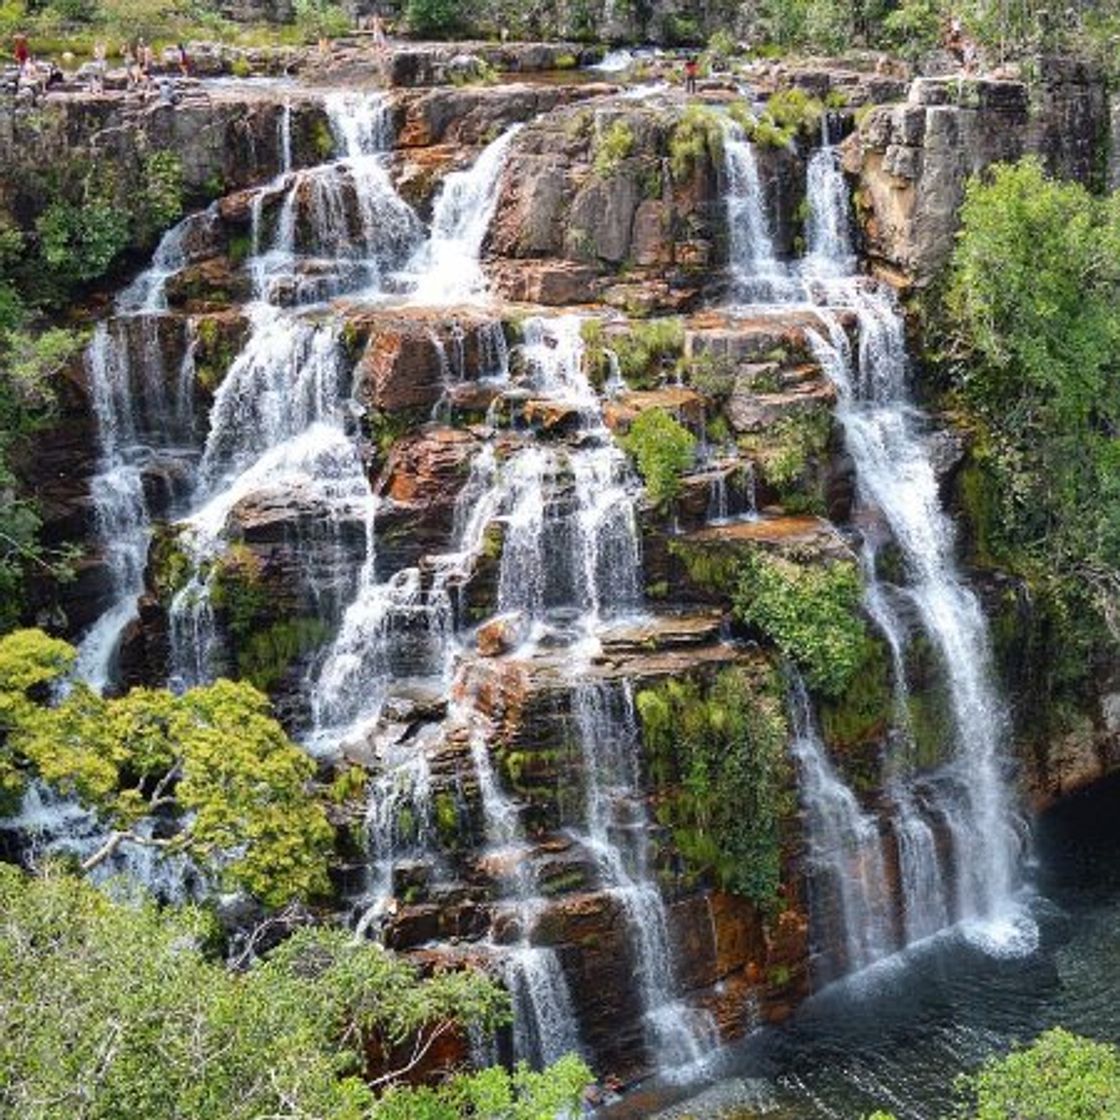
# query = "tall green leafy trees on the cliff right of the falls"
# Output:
<box><xmin>945</xmin><ymin>159</ymin><xmax>1120</xmax><ymax>698</ymax></box>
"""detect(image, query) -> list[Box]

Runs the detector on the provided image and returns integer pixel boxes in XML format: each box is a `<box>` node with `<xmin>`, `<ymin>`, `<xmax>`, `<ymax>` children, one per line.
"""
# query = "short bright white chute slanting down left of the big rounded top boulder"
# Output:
<box><xmin>409</xmin><ymin>124</ymin><xmax>521</xmax><ymax>307</ymax></box>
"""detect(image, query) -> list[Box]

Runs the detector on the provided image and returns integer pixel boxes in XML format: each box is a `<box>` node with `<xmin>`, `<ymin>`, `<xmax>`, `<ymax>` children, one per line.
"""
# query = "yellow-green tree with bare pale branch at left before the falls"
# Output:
<box><xmin>0</xmin><ymin>631</ymin><xmax>334</xmax><ymax>905</ymax></box>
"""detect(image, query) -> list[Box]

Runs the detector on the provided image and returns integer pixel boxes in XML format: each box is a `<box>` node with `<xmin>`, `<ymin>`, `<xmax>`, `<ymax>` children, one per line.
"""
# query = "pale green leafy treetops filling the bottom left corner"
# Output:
<box><xmin>0</xmin><ymin>866</ymin><xmax>589</xmax><ymax>1120</ymax></box>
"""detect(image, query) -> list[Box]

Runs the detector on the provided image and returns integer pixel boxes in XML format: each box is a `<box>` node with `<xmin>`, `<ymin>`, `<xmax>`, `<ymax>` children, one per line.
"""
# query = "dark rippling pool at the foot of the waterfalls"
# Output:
<box><xmin>607</xmin><ymin>781</ymin><xmax>1120</xmax><ymax>1120</ymax></box>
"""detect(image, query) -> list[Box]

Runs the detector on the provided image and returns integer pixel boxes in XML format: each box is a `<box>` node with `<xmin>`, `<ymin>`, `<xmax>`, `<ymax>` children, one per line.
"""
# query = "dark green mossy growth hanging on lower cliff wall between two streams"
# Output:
<box><xmin>635</xmin><ymin>664</ymin><xmax>795</xmax><ymax>908</ymax></box>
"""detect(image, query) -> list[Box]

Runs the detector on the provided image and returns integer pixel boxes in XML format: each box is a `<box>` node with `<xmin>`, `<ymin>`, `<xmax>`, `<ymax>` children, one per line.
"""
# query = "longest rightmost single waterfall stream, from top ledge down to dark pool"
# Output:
<box><xmin>802</xmin><ymin>146</ymin><xmax>1037</xmax><ymax>952</ymax></box>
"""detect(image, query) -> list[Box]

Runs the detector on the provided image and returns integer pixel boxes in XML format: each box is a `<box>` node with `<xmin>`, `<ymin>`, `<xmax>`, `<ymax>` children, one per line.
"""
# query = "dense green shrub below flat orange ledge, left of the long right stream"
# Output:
<box><xmin>732</xmin><ymin>549</ymin><xmax>867</xmax><ymax>697</ymax></box>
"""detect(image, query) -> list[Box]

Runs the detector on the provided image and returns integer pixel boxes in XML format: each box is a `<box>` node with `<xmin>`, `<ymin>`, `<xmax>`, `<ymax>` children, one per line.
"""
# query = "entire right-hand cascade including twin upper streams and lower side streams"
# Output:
<box><xmin>727</xmin><ymin>122</ymin><xmax>1035</xmax><ymax>969</ymax></box>
